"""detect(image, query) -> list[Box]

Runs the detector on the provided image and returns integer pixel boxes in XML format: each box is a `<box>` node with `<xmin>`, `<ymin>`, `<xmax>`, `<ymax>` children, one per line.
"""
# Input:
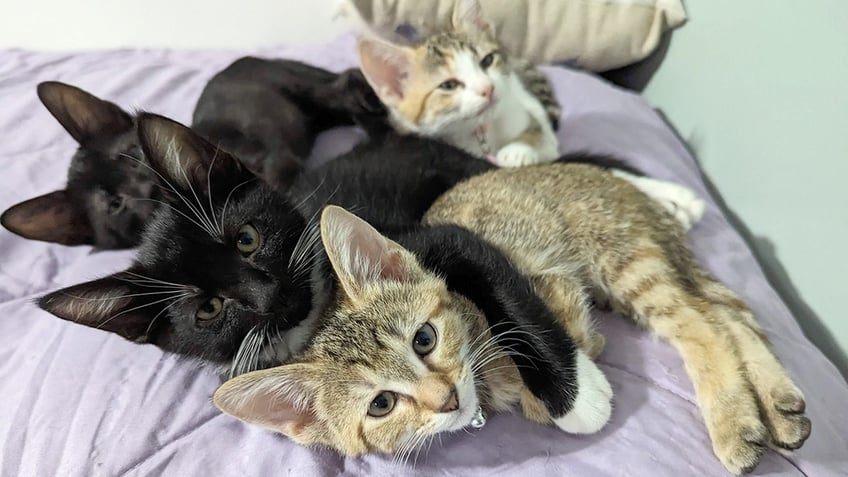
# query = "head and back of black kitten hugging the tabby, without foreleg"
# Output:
<box><xmin>39</xmin><ymin>114</ymin><xmax>491</xmax><ymax>372</ymax></box>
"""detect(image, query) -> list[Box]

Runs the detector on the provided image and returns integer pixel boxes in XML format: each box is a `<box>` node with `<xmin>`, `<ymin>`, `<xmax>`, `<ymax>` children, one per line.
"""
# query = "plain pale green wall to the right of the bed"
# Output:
<box><xmin>645</xmin><ymin>0</ymin><xmax>848</xmax><ymax>373</ymax></box>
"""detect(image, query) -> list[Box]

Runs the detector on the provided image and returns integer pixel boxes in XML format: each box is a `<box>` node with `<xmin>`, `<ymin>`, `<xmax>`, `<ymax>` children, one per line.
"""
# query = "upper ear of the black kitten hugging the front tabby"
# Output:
<box><xmin>138</xmin><ymin>113</ymin><xmax>254</xmax><ymax>197</ymax></box>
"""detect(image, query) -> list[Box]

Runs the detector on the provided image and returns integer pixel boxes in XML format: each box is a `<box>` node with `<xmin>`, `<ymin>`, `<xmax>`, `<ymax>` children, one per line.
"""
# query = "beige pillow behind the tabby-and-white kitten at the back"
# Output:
<box><xmin>334</xmin><ymin>0</ymin><xmax>686</xmax><ymax>71</ymax></box>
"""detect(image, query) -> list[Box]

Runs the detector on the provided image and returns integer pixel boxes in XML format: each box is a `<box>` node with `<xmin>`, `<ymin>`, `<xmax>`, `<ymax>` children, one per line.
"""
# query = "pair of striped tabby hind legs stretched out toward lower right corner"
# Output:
<box><xmin>600</xmin><ymin>242</ymin><xmax>810</xmax><ymax>473</ymax></box>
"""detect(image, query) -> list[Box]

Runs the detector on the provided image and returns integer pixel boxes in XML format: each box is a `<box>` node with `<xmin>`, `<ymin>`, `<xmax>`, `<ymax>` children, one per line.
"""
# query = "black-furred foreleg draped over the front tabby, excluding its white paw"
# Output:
<box><xmin>397</xmin><ymin>225</ymin><xmax>577</xmax><ymax>417</ymax></box>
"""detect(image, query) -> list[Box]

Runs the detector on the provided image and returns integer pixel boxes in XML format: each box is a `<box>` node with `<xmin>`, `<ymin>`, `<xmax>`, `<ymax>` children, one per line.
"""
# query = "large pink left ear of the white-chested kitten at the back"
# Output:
<box><xmin>357</xmin><ymin>37</ymin><xmax>413</xmax><ymax>106</ymax></box>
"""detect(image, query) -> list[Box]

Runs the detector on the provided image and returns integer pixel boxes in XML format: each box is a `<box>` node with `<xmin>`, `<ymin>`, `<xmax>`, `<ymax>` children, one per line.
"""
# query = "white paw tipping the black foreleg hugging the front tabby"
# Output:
<box><xmin>554</xmin><ymin>350</ymin><xmax>612</xmax><ymax>434</ymax></box>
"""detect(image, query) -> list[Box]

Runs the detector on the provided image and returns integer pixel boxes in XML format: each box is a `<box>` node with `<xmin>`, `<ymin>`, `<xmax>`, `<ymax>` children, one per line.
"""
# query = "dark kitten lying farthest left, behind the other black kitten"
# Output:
<box><xmin>0</xmin><ymin>58</ymin><xmax>383</xmax><ymax>249</ymax></box>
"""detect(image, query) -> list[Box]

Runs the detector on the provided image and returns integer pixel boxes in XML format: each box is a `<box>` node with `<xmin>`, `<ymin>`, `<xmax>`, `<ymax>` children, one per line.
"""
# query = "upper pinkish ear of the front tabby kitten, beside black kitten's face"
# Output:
<box><xmin>321</xmin><ymin>205</ymin><xmax>420</xmax><ymax>302</ymax></box>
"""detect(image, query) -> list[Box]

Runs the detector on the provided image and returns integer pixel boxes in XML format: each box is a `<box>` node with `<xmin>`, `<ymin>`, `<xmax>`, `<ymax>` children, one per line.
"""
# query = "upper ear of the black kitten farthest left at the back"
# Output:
<box><xmin>38</xmin><ymin>81</ymin><xmax>133</xmax><ymax>145</ymax></box>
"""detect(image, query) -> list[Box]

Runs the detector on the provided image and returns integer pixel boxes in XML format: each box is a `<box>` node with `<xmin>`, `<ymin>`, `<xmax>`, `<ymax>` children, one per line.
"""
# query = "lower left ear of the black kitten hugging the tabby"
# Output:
<box><xmin>38</xmin><ymin>272</ymin><xmax>159</xmax><ymax>343</ymax></box>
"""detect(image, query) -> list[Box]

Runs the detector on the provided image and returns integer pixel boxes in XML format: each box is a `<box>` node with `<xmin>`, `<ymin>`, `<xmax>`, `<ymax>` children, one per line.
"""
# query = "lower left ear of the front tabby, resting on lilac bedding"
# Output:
<box><xmin>212</xmin><ymin>363</ymin><xmax>316</xmax><ymax>445</ymax></box>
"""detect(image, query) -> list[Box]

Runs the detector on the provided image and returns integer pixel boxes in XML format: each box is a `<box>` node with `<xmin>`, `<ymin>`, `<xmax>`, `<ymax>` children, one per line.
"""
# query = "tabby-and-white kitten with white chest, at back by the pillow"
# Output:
<box><xmin>359</xmin><ymin>0</ymin><xmax>560</xmax><ymax>167</ymax></box>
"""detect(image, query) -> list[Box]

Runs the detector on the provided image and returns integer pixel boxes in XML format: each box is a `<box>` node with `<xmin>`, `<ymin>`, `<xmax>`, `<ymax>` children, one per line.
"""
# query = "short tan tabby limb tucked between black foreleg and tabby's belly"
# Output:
<box><xmin>530</xmin><ymin>274</ymin><xmax>605</xmax><ymax>359</ymax></box>
